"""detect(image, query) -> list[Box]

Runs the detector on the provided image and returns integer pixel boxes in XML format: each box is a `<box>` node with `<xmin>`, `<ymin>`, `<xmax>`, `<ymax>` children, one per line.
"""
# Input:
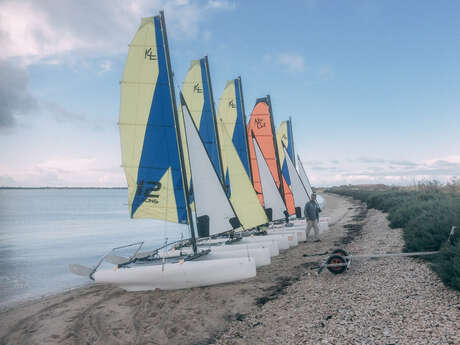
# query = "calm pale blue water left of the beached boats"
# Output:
<box><xmin>0</xmin><ymin>189</ymin><xmax>189</xmax><ymax>309</ymax></box>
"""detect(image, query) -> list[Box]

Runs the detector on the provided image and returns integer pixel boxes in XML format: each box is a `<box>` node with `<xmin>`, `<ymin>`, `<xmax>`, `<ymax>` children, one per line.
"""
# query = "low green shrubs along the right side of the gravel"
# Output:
<box><xmin>326</xmin><ymin>180</ymin><xmax>460</xmax><ymax>291</ymax></box>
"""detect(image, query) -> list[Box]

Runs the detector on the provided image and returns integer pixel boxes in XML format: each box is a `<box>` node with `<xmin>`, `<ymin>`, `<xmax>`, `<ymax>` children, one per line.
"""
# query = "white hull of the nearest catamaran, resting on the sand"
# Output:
<box><xmin>93</xmin><ymin>257</ymin><xmax>256</xmax><ymax>291</ymax></box>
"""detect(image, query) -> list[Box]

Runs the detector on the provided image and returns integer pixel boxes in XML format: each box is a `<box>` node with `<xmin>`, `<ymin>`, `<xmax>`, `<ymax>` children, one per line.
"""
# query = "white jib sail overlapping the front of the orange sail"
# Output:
<box><xmin>252</xmin><ymin>138</ymin><xmax>286</xmax><ymax>220</ymax></box>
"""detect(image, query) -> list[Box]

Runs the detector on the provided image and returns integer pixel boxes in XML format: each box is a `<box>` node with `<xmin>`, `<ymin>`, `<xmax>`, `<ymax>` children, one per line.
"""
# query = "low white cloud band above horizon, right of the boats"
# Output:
<box><xmin>303</xmin><ymin>156</ymin><xmax>460</xmax><ymax>186</ymax></box>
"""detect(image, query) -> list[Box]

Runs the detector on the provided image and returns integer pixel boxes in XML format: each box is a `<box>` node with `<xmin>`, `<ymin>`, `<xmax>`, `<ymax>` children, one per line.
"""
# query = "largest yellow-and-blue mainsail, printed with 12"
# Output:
<box><xmin>119</xmin><ymin>15</ymin><xmax>187</xmax><ymax>223</ymax></box>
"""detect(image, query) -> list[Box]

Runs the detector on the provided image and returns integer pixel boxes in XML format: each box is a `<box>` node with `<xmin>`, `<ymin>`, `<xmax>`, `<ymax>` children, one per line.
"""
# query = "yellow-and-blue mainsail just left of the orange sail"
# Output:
<box><xmin>217</xmin><ymin>78</ymin><xmax>251</xmax><ymax>177</ymax></box>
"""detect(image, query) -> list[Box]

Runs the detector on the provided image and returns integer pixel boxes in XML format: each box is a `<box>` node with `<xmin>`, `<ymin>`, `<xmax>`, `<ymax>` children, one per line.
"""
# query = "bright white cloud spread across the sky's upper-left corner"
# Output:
<box><xmin>0</xmin><ymin>0</ymin><xmax>235</xmax><ymax>65</ymax></box>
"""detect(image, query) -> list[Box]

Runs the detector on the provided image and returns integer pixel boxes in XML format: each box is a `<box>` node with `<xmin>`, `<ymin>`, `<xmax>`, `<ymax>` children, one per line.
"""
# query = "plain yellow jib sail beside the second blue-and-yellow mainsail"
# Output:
<box><xmin>217</xmin><ymin>117</ymin><xmax>268</xmax><ymax>229</ymax></box>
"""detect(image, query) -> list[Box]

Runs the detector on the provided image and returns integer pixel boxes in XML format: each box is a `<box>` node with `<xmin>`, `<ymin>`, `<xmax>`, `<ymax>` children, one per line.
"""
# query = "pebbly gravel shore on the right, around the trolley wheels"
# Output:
<box><xmin>214</xmin><ymin>196</ymin><xmax>460</xmax><ymax>345</ymax></box>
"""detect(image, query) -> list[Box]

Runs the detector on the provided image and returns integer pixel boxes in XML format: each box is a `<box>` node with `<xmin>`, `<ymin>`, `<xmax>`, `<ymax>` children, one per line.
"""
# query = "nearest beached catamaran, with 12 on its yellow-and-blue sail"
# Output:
<box><xmin>69</xmin><ymin>12</ymin><xmax>256</xmax><ymax>291</ymax></box>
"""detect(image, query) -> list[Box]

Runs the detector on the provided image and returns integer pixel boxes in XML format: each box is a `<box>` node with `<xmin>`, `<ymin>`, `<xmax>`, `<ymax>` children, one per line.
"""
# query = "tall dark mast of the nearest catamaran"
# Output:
<box><xmin>160</xmin><ymin>11</ymin><xmax>198</xmax><ymax>254</ymax></box>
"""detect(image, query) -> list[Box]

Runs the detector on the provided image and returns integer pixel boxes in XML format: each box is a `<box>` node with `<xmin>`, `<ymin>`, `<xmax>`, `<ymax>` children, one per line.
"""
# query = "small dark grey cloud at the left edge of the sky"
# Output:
<box><xmin>0</xmin><ymin>60</ymin><xmax>37</xmax><ymax>131</ymax></box>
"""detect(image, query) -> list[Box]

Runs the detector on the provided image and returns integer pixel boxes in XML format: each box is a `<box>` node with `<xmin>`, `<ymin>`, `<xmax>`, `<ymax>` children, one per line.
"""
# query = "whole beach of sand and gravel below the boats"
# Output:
<box><xmin>0</xmin><ymin>194</ymin><xmax>460</xmax><ymax>345</ymax></box>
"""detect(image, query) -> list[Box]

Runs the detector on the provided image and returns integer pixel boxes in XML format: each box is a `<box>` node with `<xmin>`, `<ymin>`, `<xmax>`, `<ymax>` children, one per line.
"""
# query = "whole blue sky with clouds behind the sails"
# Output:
<box><xmin>0</xmin><ymin>0</ymin><xmax>460</xmax><ymax>187</ymax></box>
